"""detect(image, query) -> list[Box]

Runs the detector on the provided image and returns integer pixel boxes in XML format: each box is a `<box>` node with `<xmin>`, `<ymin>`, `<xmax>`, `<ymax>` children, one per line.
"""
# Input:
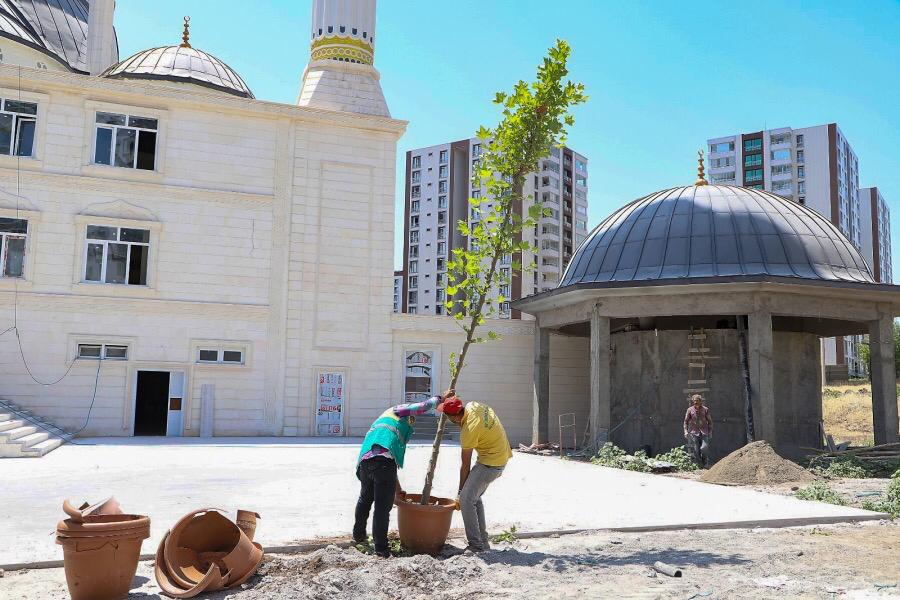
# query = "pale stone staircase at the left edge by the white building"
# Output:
<box><xmin>0</xmin><ymin>398</ymin><xmax>74</xmax><ymax>458</ymax></box>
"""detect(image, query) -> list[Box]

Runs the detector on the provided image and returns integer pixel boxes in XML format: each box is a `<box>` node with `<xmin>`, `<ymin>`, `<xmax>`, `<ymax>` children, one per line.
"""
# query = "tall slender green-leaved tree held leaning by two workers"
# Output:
<box><xmin>421</xmin><ymin>40</ymin><xmax>587</xmax><ymax>504</ymax></box>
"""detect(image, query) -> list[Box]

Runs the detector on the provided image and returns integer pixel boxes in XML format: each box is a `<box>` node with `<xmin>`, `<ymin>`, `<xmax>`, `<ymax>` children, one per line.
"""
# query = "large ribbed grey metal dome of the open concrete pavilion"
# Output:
<box><xmin>559</xmin><ymin>185</ymin><xmax>874</xmax><ymax>287</ymax></box>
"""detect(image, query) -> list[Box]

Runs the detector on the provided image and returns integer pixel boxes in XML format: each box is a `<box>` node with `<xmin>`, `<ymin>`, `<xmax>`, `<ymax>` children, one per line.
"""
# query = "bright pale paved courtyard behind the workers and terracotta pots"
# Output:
<box><xmin>0</xmin><ymin>438</ymin><xmax>875</xmax><ymax>566</ymax></box>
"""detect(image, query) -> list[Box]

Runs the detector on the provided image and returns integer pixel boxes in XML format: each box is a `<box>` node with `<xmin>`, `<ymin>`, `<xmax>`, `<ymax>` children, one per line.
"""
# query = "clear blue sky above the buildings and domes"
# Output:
<box><xmin>116</xmin><ymin>0</ymin><xmax>900</xmax><ymax>280</ymax></box>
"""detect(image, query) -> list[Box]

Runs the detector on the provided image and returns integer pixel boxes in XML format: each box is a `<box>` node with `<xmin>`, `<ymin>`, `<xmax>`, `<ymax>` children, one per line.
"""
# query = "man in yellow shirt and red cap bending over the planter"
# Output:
<box><xmin>437</xmin><ymin>395</ymin><xmax>512</xmax><ymax>552</ymax></box>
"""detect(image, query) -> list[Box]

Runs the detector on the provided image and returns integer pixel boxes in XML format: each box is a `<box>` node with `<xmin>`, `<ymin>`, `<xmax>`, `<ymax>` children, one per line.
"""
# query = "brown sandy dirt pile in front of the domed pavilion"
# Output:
<box><xmin>700</xmin><ymin>441</ymin><xmax>815</xmax><ymax>485</ymax></box>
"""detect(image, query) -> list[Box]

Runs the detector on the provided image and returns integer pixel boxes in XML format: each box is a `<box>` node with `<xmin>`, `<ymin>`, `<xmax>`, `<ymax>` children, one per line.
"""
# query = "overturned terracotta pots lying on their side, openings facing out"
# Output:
<box><xmin>154</xmin><ymin>508</ymin><xmax>263</xmax><ymax>598</ymax></box>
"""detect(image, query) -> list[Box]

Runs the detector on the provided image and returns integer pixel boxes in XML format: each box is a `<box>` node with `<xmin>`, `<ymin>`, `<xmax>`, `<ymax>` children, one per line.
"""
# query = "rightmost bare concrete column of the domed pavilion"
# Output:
<box><xmin>869</xmin><ymin>311</ymin><xmax>900</xmax><ymax>444</ymax></box>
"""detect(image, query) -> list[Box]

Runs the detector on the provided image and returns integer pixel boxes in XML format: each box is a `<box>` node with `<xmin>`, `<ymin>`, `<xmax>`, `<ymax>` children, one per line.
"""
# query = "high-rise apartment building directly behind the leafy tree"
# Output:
<box><xmin>402</xmin><ymin>138</ymin><xmax>588</xmax><ymax>318</ymax></box>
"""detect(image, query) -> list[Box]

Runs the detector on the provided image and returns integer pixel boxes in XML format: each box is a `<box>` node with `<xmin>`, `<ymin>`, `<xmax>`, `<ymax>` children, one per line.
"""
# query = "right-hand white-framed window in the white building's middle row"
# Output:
<box><xmin>84</xmin><ymin>225</ymin><xmax>150</xmax><ymax>285</ymax></box>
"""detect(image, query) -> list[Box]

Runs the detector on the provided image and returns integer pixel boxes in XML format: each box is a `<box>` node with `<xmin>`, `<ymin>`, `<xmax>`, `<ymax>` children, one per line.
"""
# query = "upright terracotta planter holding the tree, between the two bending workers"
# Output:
<box><xmin>395</xmin><ymin>494</ymin><xmax>456</xmax><ymax>556</ymax></box>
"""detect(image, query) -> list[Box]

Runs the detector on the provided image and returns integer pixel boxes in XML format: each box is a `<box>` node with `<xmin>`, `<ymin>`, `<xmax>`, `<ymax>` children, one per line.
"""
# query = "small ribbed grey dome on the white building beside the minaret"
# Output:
<box><xmin>100</xmin><ymin>46</ymin><xmax>254</xmax><ymax>98</ymax></box>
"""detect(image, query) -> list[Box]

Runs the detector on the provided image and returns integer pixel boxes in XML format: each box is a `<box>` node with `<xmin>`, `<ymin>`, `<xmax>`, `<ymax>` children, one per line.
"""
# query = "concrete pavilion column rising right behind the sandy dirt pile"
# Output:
<box><xmin>747</xmin><ymin>311</ymin><xmax>777</xmax><ymax>446</ymax></box>
